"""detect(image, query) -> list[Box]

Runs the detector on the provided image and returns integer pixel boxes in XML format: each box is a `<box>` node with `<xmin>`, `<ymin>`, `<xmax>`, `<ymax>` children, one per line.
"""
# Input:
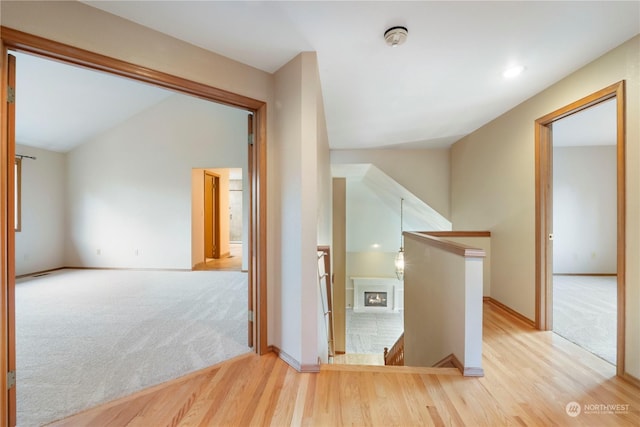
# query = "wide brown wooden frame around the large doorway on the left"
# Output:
<box><xmin>0</xmin><ymin>27</ymin><xmax>270</xmax><ymax>425</ymax></box>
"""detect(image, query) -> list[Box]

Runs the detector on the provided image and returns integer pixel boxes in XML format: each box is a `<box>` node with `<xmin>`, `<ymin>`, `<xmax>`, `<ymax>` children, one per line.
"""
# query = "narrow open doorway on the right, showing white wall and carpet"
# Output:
<box><xmin>552</xmin><ymin>99</ymin><xmax>617</xmax><ymax>365</ymax></box>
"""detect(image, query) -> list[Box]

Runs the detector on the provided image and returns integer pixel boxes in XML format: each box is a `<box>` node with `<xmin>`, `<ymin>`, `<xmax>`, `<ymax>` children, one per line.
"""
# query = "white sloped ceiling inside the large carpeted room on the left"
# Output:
<box><xmin>12</xmin><ymin>52</ymin><xmax>172</xmax><ymax>152</ymax></box>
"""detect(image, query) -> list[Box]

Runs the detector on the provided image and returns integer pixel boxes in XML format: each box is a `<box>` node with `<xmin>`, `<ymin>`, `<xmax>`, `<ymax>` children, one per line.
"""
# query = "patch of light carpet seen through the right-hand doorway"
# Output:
<box><xmin>553</xmin><ymin>276</ymin><xmax>617</xmax><ymax>364</ymax></box>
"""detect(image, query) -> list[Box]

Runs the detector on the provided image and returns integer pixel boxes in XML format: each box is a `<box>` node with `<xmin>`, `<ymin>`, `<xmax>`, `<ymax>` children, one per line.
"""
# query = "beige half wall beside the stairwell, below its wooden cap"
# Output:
<box><xmin>404</xmin><ymin>234</ymin><xmax>483</xmax><ymax>375</ymax></box>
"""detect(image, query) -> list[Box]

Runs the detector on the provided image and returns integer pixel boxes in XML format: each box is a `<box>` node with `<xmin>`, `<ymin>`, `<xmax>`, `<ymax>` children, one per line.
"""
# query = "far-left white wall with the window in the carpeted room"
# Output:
<box><xmin>16</xmin><ymin>145</ymin><xmax>67</xmax><ymax>275</ymax></box>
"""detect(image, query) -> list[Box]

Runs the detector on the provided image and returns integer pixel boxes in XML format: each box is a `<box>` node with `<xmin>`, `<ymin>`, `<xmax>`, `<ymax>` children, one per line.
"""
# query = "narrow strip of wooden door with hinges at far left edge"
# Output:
<box><xmin>0</xmin><ymin>51</ymin><xmax>16</xmax><ymax>427</ymax></box>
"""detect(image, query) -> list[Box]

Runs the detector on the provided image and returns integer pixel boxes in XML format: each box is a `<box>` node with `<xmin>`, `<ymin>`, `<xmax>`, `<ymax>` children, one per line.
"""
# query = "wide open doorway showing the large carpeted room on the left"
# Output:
<box><xmin>14</xmin><ymin>53</ymin><xmax>251</xmax><ymax>425</ymax></box>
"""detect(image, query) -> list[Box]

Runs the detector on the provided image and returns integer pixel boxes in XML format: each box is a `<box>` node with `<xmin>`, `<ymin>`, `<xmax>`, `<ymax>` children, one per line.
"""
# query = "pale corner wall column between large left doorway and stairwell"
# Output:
<box><xmin>269</xmin><ymin>52</ymin><xmax>331</xmax><ymax>371</ymax></box>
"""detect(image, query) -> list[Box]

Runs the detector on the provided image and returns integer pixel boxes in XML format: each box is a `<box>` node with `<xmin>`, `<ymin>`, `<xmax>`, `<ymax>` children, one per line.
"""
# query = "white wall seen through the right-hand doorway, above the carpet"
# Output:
<box><xmin>553</xmin><ymin>145</ymin><xmax>617</xmax><ymax>274</ymax></box>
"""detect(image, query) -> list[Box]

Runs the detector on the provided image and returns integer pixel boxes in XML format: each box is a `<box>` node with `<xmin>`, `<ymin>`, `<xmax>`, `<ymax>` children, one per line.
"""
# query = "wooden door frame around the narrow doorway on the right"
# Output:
<box><xmin>535</xmin><ymin>80</ymin><xmax>626</xmax><ymax>376</ymax></box>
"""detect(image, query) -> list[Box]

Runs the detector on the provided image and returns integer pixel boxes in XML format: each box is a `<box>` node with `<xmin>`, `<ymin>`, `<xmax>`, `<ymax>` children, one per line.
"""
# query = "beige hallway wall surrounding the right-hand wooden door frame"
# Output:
<box><xmin>451</xmin><ymin>36</ymin><xmax>640</xmax><ymax>378</ymax></box>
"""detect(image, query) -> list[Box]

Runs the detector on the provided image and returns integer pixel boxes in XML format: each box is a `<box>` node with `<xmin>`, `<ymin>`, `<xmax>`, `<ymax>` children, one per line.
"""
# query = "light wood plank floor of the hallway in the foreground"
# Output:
<box><xmin>47</xmin><ymin>303</ymin><xmax>640</xmax><ymax>426</ymax></box>
